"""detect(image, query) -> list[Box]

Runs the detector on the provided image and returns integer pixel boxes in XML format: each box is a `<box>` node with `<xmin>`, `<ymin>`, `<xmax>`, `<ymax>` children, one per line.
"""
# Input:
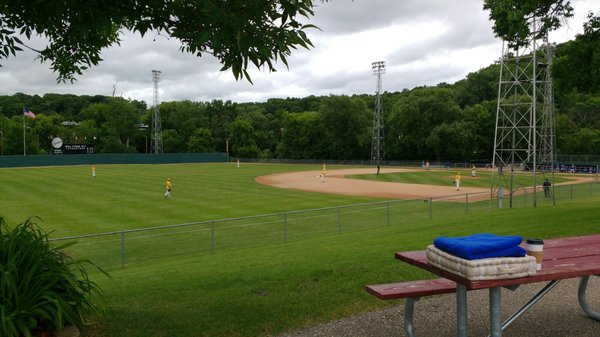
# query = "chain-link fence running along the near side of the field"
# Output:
<box><xmin>52</xmin><ymin>182</ymin><xmax>600</xmax><ymax>270</ymax></box>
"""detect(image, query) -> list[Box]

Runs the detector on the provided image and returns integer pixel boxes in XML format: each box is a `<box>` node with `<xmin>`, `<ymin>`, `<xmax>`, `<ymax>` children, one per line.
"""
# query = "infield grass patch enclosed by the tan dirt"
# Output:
<box><xmin>347</xmin><ymin>169</ymin><xmax>574</xmax><ymax>188</ymax></box>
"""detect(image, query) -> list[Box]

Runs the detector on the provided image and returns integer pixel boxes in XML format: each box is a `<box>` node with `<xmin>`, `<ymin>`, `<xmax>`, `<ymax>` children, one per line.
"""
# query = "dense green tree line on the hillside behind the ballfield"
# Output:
<box><xmin>0</xmin><ymin>14</ymin><xmax>600</xmax><ymax>161</ymax></box>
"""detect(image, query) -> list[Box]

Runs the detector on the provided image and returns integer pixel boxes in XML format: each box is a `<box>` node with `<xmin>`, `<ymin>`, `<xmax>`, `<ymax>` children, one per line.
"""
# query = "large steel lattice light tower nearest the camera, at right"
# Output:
<box><xmin>492</xmin><ymin>20</ymin><xmax>556</xmax><ymax>207</ymax></box>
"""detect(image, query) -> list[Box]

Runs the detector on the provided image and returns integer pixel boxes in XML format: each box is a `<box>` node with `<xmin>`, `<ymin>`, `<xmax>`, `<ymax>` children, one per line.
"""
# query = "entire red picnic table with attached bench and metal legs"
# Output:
<box><xmin>366</xmin><ymin>235</ymin><xmax>600</xmax><ymax>337</ymax></box>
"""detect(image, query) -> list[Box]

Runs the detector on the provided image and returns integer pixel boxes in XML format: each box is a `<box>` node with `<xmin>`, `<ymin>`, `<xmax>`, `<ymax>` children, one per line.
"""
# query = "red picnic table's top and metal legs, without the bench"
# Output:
<box><xmin>396</xmin><ymin>234</ymin><xmax>600</xmax><ymax>337</ymax></box>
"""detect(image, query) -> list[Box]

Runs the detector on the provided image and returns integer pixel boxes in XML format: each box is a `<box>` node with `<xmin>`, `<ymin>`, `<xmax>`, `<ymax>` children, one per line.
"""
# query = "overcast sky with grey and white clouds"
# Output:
<box><xmin>0</xmin><ymin>0</ymin><xmax>600</xmax><ymax>105</ymax></box>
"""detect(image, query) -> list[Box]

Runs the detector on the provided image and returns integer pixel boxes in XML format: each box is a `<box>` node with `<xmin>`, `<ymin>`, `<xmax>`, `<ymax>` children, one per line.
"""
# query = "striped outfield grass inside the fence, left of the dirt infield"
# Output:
<box><xmin>0</xmin><ymin>163</ymin><xmax>376</xmax><ymax>237</ymax></box>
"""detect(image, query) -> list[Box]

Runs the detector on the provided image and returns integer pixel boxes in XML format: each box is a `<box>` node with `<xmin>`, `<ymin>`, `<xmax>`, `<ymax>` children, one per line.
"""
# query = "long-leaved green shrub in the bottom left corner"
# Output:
<box><xmin>0</xmin><ymin>217</ymin><xmax>108</xmax><ymax>337</ymax></box>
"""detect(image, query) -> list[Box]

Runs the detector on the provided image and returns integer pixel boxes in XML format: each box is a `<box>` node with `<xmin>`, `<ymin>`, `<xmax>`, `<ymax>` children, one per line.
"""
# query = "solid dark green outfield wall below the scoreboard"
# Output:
<box><xmin>0</xmin><ymin>153</ymin><xmax>227</xmax><ymax>168</ymax></box>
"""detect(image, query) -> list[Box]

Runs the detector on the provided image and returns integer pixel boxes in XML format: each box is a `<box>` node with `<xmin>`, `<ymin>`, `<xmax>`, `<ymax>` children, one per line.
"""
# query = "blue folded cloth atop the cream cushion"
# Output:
<box><xmin>433</xmin><ymin>234</ymin><xmax>526</xmax><ymax>260</ymax></box>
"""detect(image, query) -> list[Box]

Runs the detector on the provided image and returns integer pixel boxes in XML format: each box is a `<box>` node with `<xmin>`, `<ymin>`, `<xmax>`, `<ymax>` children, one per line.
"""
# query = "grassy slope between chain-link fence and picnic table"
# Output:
<box><xmin>90</xmin><ymin>198</ymin><xmax>600</xmax><ymax>337</ymax></box>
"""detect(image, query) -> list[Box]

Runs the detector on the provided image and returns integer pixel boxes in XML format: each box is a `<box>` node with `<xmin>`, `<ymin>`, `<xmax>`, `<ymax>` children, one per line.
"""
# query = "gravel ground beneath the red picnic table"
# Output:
<box><xmin>279</xmin><ymin>277</ymin><xmax>600</xmax><ymax>337</ymax></box>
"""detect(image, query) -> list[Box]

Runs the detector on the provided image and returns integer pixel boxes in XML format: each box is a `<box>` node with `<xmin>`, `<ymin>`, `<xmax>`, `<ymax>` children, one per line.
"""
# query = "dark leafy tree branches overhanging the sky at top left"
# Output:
<box><xmin>0</xmin><ymin>0</ymin><xmax>326</xmax><ymax>82</ymax></box>
